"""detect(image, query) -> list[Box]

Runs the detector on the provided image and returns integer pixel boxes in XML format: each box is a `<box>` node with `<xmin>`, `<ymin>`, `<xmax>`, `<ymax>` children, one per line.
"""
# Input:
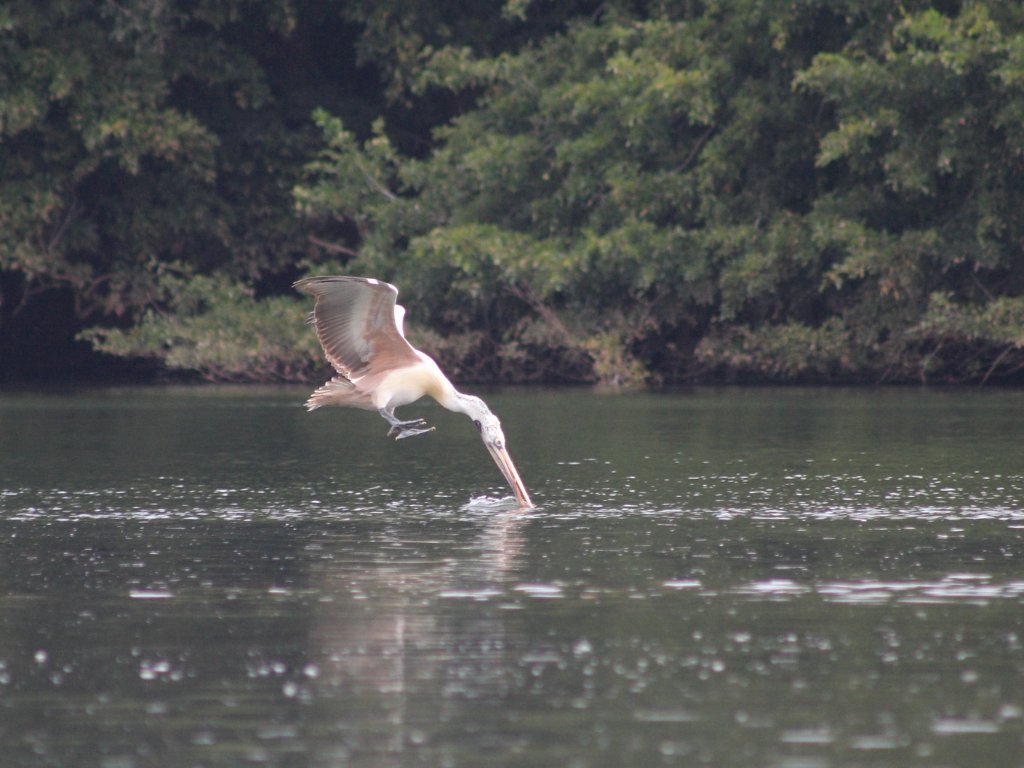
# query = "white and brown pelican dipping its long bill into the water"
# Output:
<box><xmin>295</xmin><ymin>276</ymin><xmax>534</xmax><ymax>509</ymax></box>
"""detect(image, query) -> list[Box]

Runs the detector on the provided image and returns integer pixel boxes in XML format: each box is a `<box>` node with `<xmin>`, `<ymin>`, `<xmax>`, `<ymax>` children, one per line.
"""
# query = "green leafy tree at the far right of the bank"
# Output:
<box><xmin>797</xmin><ymin>2</ymin><xmax>1024</xmax><ymax>380</ymax></box>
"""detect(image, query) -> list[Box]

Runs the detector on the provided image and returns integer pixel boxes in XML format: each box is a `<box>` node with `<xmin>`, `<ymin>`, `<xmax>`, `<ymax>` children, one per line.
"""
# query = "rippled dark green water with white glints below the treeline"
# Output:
<box><xmin>0</xmin><ymin>388</ymin><xmax>1024</xmax><ymax>768</ymax></box>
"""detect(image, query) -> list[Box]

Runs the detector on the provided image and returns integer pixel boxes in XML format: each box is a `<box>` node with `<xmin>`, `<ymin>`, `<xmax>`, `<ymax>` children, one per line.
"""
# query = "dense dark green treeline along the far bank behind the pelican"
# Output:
<box><xmin>0</xmin><ymin>0</ymin><xmax>1024</xmax><ymax>383</ymax></box>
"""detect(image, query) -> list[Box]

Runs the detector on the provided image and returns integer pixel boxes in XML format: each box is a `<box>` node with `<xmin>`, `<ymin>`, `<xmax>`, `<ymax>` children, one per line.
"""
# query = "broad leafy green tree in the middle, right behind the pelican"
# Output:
<box><xmin>298</xmin><ymin>2</ymin><xmax>842</xmax><ymax>380</ymax></box>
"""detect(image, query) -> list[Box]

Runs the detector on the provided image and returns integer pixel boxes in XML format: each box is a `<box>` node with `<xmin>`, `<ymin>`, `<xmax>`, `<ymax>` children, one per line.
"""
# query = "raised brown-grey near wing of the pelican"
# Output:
<box><xmin>295</xmin><ymin>276</ymin><xmax>420</xmax><ymax>379</ymax></box>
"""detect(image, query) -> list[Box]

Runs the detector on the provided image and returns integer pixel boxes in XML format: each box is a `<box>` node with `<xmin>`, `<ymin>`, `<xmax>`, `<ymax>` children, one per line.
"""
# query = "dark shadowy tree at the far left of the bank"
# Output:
<box><xmin>0</xmin><ymin>0</ymin><xmax>379</xmax><ymax>378</ymax></box>
